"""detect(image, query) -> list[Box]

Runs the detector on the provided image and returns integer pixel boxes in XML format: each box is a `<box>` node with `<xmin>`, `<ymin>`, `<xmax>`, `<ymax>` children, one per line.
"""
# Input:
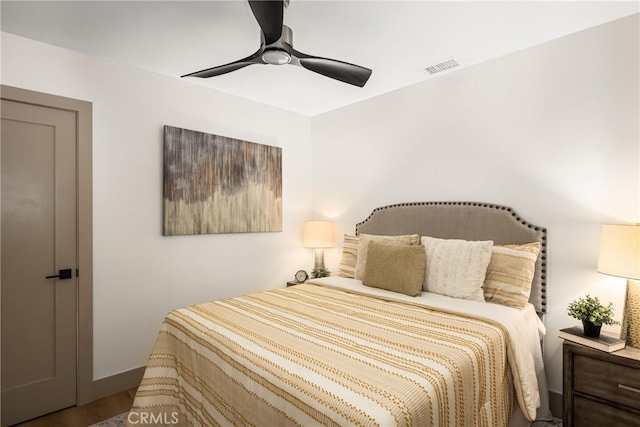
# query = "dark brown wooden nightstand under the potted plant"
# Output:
<box><xmin>562</xmin><ymin>341</ymin><xmax>640</xmax><ymax>427</ymax></box>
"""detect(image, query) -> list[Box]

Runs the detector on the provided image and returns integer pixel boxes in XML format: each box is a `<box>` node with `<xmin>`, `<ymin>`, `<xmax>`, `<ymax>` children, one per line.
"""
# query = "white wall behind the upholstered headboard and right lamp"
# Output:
<box><xmin>311</xmin><ymin>15</ymin><xmax>640</xmax><ymax>393</ymax></box>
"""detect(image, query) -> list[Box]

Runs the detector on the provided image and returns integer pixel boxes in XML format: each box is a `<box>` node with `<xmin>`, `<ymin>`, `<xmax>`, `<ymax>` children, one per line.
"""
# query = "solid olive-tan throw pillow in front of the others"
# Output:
<box><xmin>362</xmin><ymin>240</ymin><xmax>426</xmax><ymax>297</ymax></box>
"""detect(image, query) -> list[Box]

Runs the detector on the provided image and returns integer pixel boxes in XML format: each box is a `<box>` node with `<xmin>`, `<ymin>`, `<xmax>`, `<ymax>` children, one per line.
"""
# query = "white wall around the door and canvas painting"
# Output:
<box><xmin>2</xmin><ymin>33</ymin><xmax>313</xmax><ymax>379</ymax></box>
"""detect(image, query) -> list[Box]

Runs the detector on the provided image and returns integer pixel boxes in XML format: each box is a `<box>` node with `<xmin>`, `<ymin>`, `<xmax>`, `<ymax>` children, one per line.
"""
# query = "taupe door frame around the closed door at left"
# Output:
<box><xmin>0</xmin><ymin>85</ymin><xmax>93</xmax><ymax>406</ymax></box>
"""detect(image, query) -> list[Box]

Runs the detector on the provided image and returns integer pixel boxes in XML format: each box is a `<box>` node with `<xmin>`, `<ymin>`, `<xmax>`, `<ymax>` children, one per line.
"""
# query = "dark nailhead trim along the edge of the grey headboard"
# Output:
<box><xmin>356</xmin><ymin>202</ymin><xmax>547</xmax><ymax>313</ymax></box>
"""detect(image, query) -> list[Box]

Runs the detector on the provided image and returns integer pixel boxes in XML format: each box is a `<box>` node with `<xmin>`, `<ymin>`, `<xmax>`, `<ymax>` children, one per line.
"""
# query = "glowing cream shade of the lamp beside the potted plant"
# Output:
<box><xmin>598</xmin><ymin>224</ymin><xmax>640</xmax><ymax>279</ymax></box>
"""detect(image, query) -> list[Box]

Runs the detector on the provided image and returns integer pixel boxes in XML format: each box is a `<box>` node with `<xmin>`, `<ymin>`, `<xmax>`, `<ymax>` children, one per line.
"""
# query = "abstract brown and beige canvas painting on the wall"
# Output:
<box><xmin>163</xmin><ymin>126</ymin><xmax>282</xmax><ymax>236</ymax></box>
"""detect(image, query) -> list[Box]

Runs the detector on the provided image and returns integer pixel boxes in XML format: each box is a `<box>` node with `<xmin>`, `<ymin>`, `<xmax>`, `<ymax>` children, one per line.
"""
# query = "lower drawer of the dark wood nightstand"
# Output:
<box><xmin>573</xmin><ymin>396</ymin><xmax>640</xmax><ymax>427</ymax></box>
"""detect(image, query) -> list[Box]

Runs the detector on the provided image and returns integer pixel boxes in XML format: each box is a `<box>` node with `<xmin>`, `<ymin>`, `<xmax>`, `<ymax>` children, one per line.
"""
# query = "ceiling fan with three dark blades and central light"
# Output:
<box><xmin>182</xmin><ymin>0</ymin><xmax>371</xmax><ymax>87</ymax></box>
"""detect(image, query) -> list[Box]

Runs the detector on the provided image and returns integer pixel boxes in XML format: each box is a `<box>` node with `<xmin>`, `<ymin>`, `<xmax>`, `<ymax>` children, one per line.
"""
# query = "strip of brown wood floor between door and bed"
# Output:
<box><xmin>16</xmin><ymin>388</ymin><xmax>136</xmax><ymax>427</ymax></box>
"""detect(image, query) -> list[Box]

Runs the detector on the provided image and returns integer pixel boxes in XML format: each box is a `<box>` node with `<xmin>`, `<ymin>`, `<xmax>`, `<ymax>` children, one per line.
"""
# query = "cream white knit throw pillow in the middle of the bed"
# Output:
<box><xmin>422</xmin><ymin>236</ymin><xmax>493</xmax><ymax>301</ymax></box>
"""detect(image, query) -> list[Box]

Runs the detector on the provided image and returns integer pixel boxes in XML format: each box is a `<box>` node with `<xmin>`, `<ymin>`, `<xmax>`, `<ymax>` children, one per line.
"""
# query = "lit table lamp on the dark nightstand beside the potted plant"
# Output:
<box><xmin>598</xmin><ymin>224</ymin><xmax>640</xmax><ymax>348</ymax></box>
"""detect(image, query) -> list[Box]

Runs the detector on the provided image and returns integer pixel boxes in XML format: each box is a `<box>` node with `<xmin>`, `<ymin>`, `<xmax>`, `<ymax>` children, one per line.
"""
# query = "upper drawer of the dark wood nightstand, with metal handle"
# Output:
<box><xmin>573</xmin><ymin>354</ymin><xmax>640</xmax><ymax>409</ymax></box>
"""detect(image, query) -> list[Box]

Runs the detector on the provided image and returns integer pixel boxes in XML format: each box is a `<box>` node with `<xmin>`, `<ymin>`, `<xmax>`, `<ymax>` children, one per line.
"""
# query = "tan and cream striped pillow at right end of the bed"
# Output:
<box><xmin>483</xmin><ymin>242</ymin><xmax>540</xmax><ymax>308</ymax></box>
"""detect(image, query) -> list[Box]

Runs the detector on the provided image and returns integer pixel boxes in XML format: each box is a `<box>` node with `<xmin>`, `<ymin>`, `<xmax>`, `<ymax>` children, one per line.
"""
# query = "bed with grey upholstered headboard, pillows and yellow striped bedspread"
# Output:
<box><xmin>128</xmin><ymin>202</ymin><xmax>549</xmax><ymax>426</ymax></box>
